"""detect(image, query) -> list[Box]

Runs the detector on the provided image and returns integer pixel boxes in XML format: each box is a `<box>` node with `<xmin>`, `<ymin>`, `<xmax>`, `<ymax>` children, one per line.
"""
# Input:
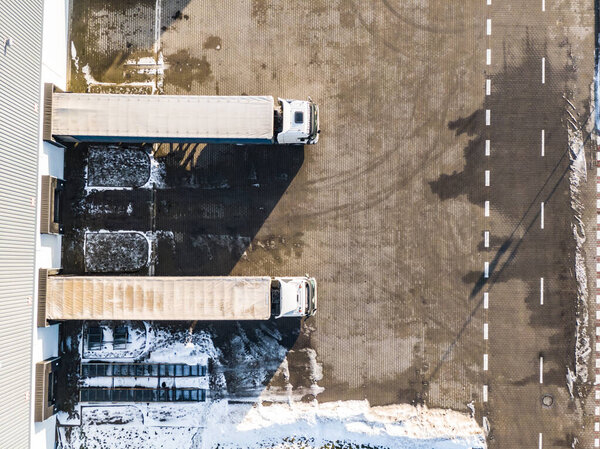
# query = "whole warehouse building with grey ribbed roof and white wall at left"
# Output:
<box><xmin>0</xmin><ymin>0</ymin><xmax>69</xmax><ymax>449</ymax></box>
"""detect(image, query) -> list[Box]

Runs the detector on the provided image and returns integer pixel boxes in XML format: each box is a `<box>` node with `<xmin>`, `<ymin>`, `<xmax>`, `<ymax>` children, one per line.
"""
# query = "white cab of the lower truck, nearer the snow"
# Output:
<box><xmin>273</xmin><ymin>276</ymin><xmax>317</xmax><ymax>318</ymax></box>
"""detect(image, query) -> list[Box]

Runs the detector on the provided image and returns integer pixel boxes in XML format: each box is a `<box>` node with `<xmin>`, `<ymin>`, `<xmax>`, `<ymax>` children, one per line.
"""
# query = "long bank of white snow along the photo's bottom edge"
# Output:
<box><xmin>59</xmin><ymin>400</ymin><xmax>486</xmax><ymax>449</ymax></box>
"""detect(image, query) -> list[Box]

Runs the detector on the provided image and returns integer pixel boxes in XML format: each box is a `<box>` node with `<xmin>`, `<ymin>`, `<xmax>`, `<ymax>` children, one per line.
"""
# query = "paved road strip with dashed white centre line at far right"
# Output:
<box><xmin>478</xmin><ymin>2</ymin><xmax>595</xmax><ymax>448</ymax></box>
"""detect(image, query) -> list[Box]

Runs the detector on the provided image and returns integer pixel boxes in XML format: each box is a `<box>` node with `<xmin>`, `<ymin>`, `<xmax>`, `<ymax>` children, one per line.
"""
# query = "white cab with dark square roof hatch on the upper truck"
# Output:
<box><xmin>277</xmin><ymin>98</ymin><xmax>321</xmax><ymax>145</ymax></box>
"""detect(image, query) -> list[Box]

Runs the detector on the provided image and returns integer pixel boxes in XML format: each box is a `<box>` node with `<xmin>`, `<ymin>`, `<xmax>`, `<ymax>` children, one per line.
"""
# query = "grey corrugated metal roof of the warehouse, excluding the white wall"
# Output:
<box><xmin>0</xmin><ymin>0</ymin><xmax>43</xmax><ymax>449</ymax></box>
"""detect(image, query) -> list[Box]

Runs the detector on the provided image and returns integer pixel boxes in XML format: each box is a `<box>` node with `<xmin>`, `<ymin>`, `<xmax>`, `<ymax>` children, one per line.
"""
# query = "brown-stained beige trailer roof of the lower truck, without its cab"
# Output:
<box><xmin>40</xmin><ymin>276</ymin><xmax>271</xmax><ymax>320</ymax></box>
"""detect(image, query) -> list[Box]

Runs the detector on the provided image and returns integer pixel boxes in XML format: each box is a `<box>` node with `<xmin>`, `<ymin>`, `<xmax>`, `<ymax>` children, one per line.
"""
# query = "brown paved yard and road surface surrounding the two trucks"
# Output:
<box><xmin>63</xmin><ymin>0</ymin><xmax>594</xmax><ymax>448</ymax></box>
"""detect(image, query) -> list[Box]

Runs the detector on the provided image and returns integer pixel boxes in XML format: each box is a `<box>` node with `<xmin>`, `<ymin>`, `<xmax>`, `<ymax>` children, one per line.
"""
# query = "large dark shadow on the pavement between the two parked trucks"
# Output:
<box><xmin>62</xmin><ymin>144</ymin><xmax>304</xmax><ymax>276</ymax></box>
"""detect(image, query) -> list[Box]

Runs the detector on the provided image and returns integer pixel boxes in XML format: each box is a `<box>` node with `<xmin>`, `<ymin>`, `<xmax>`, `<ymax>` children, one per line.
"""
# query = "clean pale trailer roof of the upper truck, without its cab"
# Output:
<box><xmin>51</xmin><ymin>92</ymin><xmax>274</xmax><ymax>141</ymax></box>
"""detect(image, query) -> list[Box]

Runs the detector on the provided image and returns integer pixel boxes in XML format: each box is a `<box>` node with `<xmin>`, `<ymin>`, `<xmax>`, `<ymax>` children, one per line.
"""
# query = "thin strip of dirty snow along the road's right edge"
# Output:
<box><xmin>567</xmin><ymin>121</ymin><xmax>592</xmax><ymax>386</ymax></box>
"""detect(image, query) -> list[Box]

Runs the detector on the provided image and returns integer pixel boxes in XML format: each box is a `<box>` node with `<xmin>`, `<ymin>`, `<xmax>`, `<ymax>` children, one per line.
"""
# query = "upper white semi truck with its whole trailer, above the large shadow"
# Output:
<box><xmin>44</xmin><ymin>84</ymin><xmax>320</xmax><ymax>145</ymax></box>
